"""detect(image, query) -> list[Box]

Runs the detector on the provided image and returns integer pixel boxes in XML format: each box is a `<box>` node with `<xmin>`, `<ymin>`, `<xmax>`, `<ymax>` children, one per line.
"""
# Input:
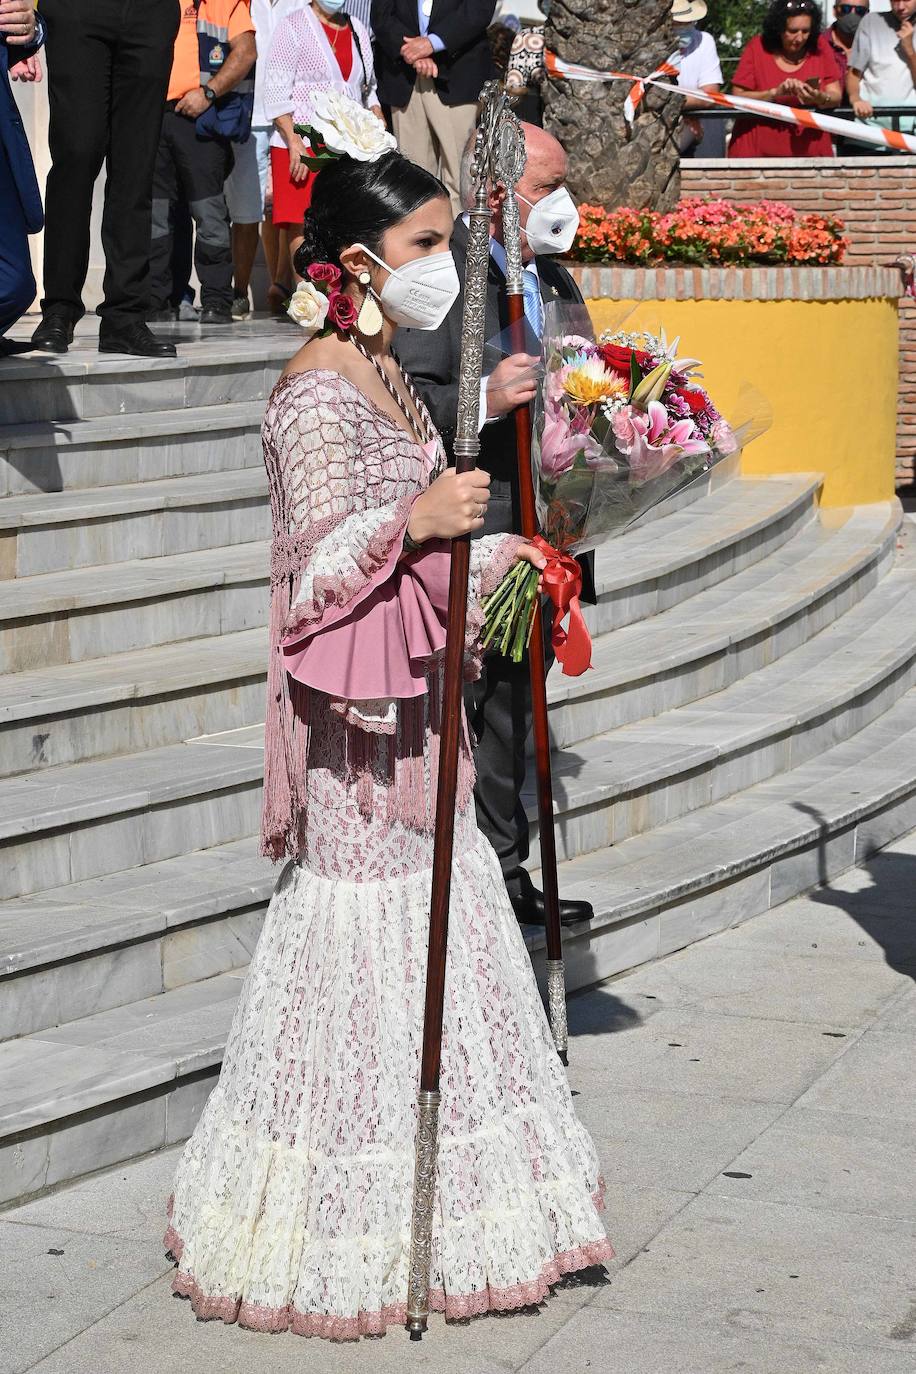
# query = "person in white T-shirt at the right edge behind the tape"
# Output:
<box><xmin>846</xmin><ymin>0</ymin><xmax>916</xmax><ymax>133</ymax></box>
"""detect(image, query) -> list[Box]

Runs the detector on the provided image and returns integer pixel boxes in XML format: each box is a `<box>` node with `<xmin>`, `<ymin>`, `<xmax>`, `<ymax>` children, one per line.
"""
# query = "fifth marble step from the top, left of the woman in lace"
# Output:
<box><xmin>0</xmin><ymin>627</ymin><xmax>268</xmax><ymax>776</ymax></box>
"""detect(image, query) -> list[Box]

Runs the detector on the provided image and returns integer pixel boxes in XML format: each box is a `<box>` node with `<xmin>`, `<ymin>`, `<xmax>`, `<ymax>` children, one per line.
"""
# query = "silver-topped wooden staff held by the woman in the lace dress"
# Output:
<box><xmin>407</xmin><ymin>81</ymin><xmax>505</xmax><ymax>1341</ymax></box>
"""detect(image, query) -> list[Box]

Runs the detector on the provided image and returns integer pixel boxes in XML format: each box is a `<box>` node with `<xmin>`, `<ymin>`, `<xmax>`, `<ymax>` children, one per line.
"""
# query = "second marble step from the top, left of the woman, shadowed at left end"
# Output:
<box><xmin>0</xmin><ymin>400</ymin><xmax>264</xmax><ymax>497</ymax></box>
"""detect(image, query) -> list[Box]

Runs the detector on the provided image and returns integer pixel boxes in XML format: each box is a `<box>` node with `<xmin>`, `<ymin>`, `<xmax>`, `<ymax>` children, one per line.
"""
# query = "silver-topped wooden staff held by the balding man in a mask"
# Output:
<box><xmin>501</xmin><ymin>110</ymin><xmax>569</xmax><ymax>1065</ymax></box>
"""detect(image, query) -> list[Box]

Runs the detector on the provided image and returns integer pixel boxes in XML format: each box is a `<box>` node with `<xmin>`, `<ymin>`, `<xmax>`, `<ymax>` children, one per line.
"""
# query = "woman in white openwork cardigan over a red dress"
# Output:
<box><xmin>264</xmin><ymin>0</ymin><xmax>382</xmax><ymax>278</ymax></box>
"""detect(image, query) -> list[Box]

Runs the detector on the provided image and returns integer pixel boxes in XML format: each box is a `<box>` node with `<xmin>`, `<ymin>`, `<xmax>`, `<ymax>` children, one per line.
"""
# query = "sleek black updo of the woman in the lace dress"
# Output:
<box><xmin>294</xmin><ymin>150</ymin><xmax>448</xmax><ymax>276</ymax></box>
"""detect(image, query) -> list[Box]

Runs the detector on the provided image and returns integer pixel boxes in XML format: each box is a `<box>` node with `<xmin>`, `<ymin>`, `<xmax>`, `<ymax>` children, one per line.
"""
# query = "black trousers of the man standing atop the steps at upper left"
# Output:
<box><xmin>40</xmin><ymin>0</ymin><xmax>180</xmax><ymax>326</ymax></box>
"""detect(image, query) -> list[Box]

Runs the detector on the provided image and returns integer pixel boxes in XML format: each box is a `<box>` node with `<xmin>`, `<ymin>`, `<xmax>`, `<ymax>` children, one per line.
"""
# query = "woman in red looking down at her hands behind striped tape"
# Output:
<box><xmin>728</xmin><ymin>0</ymin><xmax>842</xmax><ymax>158</ymax></box>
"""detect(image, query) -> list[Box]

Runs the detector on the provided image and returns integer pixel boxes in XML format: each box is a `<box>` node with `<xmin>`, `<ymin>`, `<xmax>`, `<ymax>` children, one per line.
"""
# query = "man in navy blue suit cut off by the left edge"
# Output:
<box><xmin>0</xmin><ymin>0</ymin><xmax>44</xmax><ymax>356</ymax></box>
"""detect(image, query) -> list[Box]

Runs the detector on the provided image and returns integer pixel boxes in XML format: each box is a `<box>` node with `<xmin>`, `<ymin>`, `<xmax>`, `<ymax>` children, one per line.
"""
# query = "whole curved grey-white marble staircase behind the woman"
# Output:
<box><xmin>0</xmin><ymin>322</ymin><xmax>916</xmax><ymax>1202</ymax></box>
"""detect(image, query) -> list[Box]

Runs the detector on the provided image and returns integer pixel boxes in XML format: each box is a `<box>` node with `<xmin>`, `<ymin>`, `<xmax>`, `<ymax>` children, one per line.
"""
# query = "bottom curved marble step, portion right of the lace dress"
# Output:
<box><xmin>529</xmin><ymin>690</ymin><xmax>916</xmax><ymax>987</ymax></box>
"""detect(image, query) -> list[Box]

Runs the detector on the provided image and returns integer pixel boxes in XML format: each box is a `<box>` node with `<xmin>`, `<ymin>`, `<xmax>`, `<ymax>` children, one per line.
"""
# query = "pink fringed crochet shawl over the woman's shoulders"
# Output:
<box><xmin>261</xmin><ymin>371</ymin><xmax>486</xmax><ymax>860</ymax></box>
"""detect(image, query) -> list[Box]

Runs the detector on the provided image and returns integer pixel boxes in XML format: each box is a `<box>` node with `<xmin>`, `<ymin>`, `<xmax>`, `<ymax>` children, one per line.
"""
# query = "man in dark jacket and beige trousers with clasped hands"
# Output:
<box><xmin>372</xmin><ymin>0</ymin><xmax>496</xmax><ymax>214</ymax></box>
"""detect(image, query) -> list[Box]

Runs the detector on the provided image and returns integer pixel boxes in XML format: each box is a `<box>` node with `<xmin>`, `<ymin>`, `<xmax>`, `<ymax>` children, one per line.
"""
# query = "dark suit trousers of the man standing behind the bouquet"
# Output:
<box><xmin>464</xmin><ymin>480</ymin><xmax>553</xmax><ymax>896</ymax></box>
